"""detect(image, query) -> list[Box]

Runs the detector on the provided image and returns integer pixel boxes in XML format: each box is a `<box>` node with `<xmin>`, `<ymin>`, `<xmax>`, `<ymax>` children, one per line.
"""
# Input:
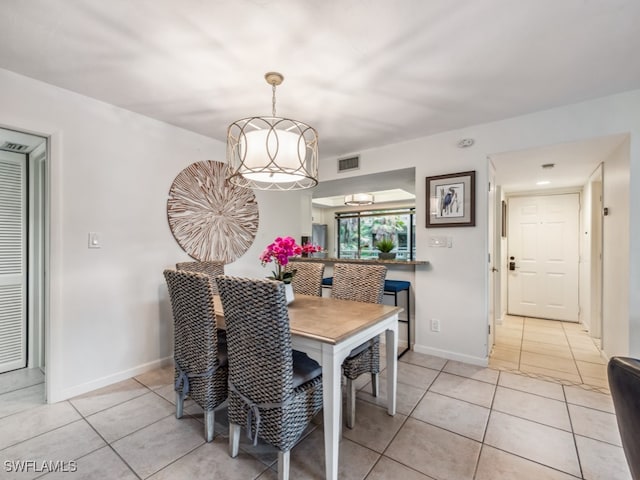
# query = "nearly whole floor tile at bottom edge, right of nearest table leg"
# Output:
<box><xmin>385</xmin><ymin>418</ymin><xmax>481</xmax><ymax>480</ymax></box>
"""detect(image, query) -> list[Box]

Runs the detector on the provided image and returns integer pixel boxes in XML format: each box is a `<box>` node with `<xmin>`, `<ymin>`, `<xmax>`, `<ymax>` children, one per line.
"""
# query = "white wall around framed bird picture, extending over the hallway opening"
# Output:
<box><xmin>320</xmin><ymin>91</ymin><xmax>640</xmax><ymax>364</ymax></box>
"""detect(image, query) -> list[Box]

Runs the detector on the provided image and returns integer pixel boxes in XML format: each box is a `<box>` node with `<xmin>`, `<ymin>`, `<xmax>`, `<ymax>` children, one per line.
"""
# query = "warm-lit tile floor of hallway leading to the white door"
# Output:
<box><xmin>489</xmin><ymin>315</ymin><xmax>609</xmax><ymax>393</ymax></box>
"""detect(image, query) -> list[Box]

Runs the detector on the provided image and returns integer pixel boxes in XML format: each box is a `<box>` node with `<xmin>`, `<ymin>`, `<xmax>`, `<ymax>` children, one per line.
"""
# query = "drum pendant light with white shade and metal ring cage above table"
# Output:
<box><xmin>227</xmin><ymin>72</ymin><xmax>318</xmax><ymax>191</ymax></box>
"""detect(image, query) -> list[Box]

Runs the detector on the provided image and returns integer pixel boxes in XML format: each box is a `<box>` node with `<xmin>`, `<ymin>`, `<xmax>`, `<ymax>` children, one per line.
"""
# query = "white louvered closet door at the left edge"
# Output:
<box><xmin>0</xmin><ymin>152</ymin><xmax>27</xmax><ymax>373</ymax></box>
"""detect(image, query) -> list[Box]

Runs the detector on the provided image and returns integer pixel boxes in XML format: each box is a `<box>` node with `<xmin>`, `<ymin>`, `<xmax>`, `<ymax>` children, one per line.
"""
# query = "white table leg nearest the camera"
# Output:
<box><xmin>322</xmin><ymin>345</ymin><xmax>342</xmax><ymax>480</ymax></box>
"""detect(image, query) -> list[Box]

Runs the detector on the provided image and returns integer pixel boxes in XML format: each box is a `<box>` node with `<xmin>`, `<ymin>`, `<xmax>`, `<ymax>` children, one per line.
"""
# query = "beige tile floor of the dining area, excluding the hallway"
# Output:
<box><xmin>0</xmin><ymin>342</ymin><xmax>630</xmax><ymax>480</ymax></box>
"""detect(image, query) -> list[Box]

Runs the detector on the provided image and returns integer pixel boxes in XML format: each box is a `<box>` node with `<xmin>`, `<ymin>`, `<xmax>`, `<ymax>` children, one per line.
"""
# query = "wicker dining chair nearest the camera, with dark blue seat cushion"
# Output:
<box><xmin>217</xmin><ymin>276</ymin><xmax>322</xmax><ymax>480</ymax></box>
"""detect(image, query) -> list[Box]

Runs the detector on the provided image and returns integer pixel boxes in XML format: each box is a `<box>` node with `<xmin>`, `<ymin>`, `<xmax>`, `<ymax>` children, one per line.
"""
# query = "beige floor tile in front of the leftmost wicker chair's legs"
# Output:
<box><xmin>112</xmin><ymin>415</ymin><xmax>205</xmax><ymax>478</ymax></box>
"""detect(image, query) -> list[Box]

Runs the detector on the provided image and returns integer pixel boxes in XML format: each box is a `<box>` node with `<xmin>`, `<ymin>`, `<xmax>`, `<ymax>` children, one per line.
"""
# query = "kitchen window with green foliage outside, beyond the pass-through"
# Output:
<box><xmin>336</xmin><ymin>208</ymin><xmax>416</xmax><ymax>260</ymax></box>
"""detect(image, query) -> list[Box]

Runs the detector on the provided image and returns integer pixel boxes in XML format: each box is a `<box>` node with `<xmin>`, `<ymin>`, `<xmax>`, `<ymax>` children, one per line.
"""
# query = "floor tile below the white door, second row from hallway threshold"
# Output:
<box><xmin>492</xmin><ymin>386</ymin><xmax>571</xmax><ymax>432</ymax></box>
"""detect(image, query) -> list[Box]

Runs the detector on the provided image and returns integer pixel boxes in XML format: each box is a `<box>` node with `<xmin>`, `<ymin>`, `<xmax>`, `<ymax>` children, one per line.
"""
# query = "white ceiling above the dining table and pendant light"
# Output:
<box><xmin>0</xmin><ymin>0</ymin><xmax>640</xmax><ymax>191</ymax></box>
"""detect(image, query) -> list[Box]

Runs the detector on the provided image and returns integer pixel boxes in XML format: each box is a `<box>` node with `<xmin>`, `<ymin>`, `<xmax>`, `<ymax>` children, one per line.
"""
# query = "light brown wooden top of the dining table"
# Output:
<box><xmin>214</xmin><ymin>294</ymin><xmax>403</xmax><ymax>345</ymax></box>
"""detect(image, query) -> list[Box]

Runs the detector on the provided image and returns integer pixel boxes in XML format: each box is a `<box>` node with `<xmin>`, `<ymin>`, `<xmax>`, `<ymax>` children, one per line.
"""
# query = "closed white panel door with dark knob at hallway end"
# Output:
<box><xmin>507</xmin><ymin>193</ymin><xmax>580</xmax><ymax>322</ymax></box>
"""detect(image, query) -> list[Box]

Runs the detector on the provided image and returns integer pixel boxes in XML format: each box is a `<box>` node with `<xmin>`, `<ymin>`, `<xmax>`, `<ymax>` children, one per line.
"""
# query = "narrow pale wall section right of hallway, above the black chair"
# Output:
<box><xmin>602</xmin><ymin>141</ymin><xmax>640</xmax><ymax>356</ymax></box>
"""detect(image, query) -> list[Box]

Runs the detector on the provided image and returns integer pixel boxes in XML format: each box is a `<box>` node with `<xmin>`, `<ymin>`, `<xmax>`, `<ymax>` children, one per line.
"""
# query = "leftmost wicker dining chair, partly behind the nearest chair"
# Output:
<box><xmin>164</xmin><ymin>270</ymin><xmax>228</xmax><ymax>442</ymax></box>
